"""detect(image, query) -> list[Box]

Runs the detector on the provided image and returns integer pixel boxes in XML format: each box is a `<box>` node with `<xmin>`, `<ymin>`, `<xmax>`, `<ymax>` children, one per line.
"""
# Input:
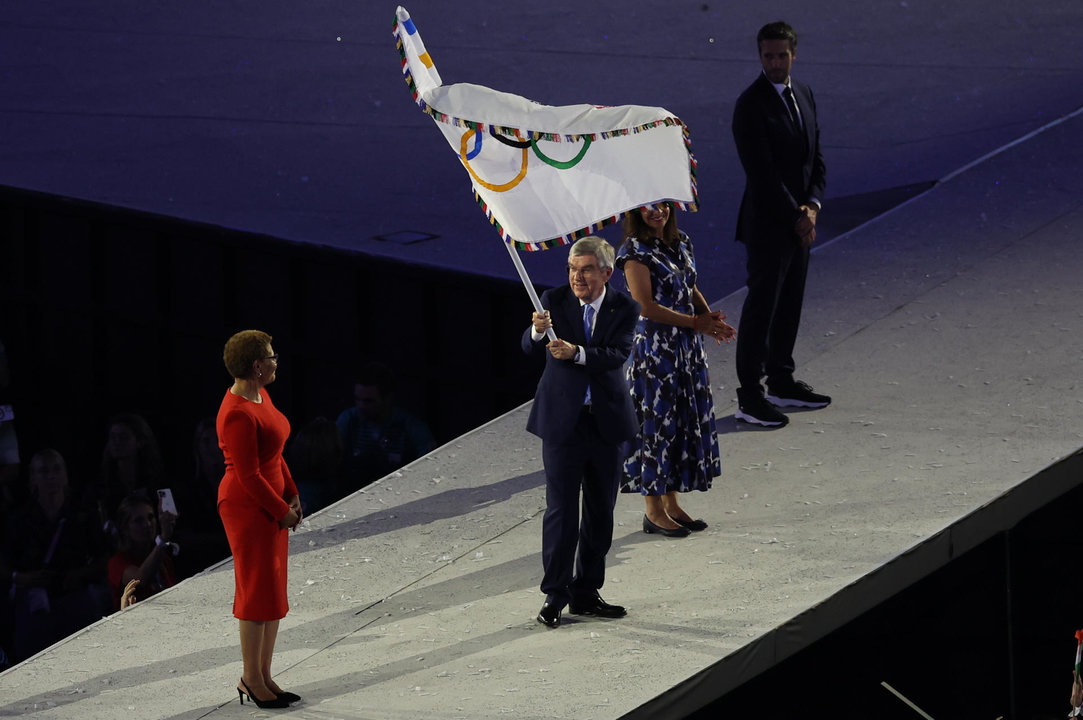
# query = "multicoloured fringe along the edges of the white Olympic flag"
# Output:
<box><xmin>391</xmin><ymin>9</ymin><xmax>700</xmax><ymax>252</ymax></box>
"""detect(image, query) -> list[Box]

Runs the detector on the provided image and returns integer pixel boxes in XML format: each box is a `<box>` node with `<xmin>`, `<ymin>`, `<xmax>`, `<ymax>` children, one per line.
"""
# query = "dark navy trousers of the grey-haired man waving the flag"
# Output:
<box><xmin>542</xmin><ymin>409</ymin><xmax>624</xmax><ymax>605</ymax></box>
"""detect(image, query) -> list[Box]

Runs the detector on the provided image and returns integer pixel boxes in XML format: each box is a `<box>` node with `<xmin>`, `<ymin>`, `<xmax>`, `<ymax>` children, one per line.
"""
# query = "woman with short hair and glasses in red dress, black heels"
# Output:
<box><xmin>217</xmin><ymin>330</ymin><xmax>301</xmax><ymax>708</ymax></box>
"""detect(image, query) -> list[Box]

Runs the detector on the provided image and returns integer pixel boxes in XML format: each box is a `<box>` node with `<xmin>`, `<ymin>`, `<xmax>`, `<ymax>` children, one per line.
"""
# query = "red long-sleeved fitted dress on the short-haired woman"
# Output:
<box><xmin>217</xmin><ymin>388</ymin><xmax>297</xmax><ymax>621</ymax></box>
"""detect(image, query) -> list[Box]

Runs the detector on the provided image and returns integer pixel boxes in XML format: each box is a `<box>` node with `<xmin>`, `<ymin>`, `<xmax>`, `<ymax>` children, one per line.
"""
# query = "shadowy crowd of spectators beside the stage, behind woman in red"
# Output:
<box><xmin>0</xmin><ymin>344</ymin><xmax>435</xmax><ymax>670</ymax></box>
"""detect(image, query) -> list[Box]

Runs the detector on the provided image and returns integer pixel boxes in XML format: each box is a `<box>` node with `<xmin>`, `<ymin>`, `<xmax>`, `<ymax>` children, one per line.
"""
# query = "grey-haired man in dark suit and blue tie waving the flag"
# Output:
<box><xmin>522</xmin><ymin>237</ymin><xmax>639</xmax><ymax>628</ymax></box>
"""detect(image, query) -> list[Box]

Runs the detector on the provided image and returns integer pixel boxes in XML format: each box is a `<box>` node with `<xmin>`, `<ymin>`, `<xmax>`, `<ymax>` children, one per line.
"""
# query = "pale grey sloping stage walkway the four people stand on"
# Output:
<box><xmin>0</xmin><ymin>99</ymin><xmax>1083</xmax><ymax>720</ymax></box>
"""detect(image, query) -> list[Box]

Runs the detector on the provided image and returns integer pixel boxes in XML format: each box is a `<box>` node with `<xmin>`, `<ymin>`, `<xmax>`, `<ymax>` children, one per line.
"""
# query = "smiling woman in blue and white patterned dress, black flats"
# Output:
<box><xmin>616</xmin><ymin>202</ymin><xmax>736</xmax><ymax>537</ymax></box>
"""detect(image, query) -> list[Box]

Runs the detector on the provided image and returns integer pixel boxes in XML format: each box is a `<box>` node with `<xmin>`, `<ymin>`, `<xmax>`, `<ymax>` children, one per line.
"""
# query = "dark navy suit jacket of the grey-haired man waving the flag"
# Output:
<box><xmin>522</xmin><ymin>285</ymin><xmax>639</xmax><ymax>444</ymax></box>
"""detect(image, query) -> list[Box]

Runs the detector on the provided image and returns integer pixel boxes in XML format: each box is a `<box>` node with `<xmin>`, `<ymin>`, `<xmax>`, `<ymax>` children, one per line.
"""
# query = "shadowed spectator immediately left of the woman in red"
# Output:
<box><xmin>172</xmin><ymin>418</ymin><xmax>230</xmax><ymax>578</ymax></box>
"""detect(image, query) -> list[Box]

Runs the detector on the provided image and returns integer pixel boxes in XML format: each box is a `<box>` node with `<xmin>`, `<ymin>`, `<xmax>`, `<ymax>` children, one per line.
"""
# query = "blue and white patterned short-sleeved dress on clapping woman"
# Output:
<box><xmin>616</xmin><ymin>233</ymin><xmax>722</xmax><ymax>495</ymax></box>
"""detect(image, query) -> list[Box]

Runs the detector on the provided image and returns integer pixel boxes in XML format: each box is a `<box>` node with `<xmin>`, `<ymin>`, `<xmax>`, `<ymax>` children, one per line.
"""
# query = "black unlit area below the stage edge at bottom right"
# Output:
<box><xmin>688</xmin><ymin>463</ymin><xmax>1083</xmax><ymax>720</ymax></box>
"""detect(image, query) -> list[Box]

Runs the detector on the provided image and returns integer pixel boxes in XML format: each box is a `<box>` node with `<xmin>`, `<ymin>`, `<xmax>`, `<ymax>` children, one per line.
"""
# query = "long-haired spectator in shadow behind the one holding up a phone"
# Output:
<box><xmin>91</xmin><ymin>413</ymin><xmax>167</xmax><ymax>538</ymax></box>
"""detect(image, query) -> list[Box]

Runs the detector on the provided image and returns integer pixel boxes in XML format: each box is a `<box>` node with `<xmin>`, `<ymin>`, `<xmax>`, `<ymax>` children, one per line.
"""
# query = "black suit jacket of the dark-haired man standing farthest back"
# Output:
<box><xmin>733</xmin><ymin>73</ymin><xmax>826</xmax><ymax>244</ymax></box>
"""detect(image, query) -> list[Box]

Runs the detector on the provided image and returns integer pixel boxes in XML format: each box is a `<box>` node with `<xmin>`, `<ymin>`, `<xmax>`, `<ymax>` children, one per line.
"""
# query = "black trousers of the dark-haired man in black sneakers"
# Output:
<box><xmin>736</xmin><ymin>238</ymin><xmax>809</xmax><ymax>395</ymax></box>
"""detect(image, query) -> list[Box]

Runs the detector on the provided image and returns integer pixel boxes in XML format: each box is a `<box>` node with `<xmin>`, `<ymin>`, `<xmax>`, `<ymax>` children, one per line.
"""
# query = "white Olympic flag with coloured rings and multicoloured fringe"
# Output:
<box><xmin>393</xmin><ymin>6</ymin><xmax>699</xmax><ymax>250</ymax></box>
